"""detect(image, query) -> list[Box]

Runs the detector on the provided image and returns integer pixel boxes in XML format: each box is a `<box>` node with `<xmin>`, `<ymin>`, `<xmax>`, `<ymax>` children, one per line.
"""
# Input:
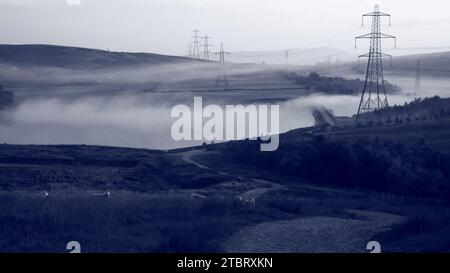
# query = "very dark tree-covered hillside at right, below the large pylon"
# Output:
<box><xmin>216</xmin><ymin>118</ymin><xmax>450</xmax><ymax>200</ymax></box>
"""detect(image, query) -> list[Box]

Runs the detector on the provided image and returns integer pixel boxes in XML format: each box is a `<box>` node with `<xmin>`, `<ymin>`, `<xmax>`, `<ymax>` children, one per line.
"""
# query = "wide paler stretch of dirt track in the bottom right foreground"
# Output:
<box><xmin>223</xmin><ymin>210</ymin><xmax>403</xmax><ymax>253</ymax></box>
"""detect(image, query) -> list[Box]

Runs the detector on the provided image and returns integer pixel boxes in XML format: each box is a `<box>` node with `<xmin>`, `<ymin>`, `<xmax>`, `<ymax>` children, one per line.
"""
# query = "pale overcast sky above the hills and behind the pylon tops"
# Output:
<box><xmin>0</xmin><ymin>0</ymin><xmax>450</xmax><ymax>55</ymax></box>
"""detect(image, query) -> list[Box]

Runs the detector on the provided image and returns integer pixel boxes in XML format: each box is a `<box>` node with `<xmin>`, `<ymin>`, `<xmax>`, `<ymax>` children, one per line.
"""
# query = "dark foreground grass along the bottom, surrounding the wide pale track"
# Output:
<box><xmin>0</xmin><ymin>188</ymin><xmax>450</xmax><ymax>253</ymax></box>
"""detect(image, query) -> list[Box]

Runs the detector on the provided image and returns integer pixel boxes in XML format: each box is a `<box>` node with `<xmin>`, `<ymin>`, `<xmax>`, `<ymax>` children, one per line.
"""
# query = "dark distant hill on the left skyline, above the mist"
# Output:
<box><xmin>0</xmin><ymin>45</ymin><xmax>193</xmax><ymax>69</ymax></box>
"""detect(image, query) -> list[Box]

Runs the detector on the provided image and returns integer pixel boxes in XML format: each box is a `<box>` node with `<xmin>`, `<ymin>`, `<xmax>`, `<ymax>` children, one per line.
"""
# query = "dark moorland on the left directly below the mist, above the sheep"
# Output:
<box><xmin>0</xmin><ymin>144</ymin><xmax>230</xmax><ymax>192</ymax></box>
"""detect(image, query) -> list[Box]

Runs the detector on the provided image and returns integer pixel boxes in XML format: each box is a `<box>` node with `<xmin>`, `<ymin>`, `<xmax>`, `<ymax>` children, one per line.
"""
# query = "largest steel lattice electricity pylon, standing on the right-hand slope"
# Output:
<box><xmin>355</xmin><ymin>5</ymin><xmax>397</xmax><ymax>125</ymax></box>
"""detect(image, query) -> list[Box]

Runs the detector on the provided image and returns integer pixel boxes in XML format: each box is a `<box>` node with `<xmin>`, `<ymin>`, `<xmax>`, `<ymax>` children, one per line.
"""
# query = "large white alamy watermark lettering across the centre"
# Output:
<box><xmin>170</xmin><ymin>97</ymin><xmax>280</xmax><ymax>152</ymax></box>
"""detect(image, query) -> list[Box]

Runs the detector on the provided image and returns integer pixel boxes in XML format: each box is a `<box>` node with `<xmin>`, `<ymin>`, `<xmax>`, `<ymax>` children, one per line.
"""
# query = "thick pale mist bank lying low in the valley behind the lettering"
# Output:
<box><xmin>0</xmin><ymin>90</ymin><xmax>418</xmax><ymax>149</ymax></box>
